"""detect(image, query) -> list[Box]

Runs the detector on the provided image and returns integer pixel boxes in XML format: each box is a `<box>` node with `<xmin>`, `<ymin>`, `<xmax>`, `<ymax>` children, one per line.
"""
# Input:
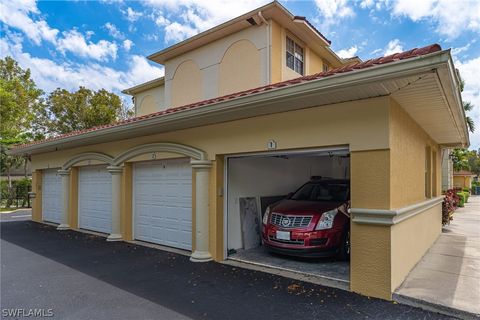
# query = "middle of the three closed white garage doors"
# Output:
<box><xmin>78</xmin><ymin>166</ymin><xmax>112</xmax><ymax>233</ymax></box>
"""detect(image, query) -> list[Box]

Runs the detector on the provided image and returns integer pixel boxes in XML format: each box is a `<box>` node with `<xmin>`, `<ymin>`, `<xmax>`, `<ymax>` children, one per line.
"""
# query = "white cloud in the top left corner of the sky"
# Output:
<box><xmin>0</xmin><ymin>0</ymin><xmax>59</xmax><ymax>45</ymax></box>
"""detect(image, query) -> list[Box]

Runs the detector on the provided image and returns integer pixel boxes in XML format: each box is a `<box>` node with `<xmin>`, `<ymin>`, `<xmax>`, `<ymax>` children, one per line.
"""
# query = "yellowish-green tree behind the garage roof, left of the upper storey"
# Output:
<box><xmin>36</xmin><ymin>87</ymin><xmax>131</xmax><ymax>136</ymax></box>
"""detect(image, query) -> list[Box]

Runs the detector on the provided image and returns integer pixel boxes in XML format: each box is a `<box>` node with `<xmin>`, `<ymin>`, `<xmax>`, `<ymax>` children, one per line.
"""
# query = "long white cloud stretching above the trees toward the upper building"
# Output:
<box><xmin>0</xmin><ymin>35</ymin><xmax>164</xmax><ymax>93</ymax></box>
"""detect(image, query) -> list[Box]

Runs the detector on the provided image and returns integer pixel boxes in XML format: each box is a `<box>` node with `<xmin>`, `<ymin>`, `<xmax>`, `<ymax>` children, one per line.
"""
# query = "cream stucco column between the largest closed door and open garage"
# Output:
<box><xmin>190</xmin><ymin>160</ymin><xmax>212</xmax><ymax>262</ymax></box>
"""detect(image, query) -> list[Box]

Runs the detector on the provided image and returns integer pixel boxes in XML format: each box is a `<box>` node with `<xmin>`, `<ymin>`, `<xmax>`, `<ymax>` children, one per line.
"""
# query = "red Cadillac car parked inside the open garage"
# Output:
<box><xmin>262</xmin><ymin>178</ymin><xmax>350</xmax><ymax>260</ymax></box>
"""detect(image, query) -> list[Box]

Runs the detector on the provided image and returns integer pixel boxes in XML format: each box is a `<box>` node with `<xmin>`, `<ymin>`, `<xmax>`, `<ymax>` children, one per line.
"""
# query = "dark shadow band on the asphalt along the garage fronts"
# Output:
<box><xmin>0</xmin><ymin>221</ymin><xmax>450</xmax><ymax>320</ymax></box>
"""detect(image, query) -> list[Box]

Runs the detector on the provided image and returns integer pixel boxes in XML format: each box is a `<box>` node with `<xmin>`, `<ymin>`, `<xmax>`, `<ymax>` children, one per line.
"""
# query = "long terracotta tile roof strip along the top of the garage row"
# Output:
<box><xmin>15</xmin><ymin>44</ymin><xmax>441</xmax><ymax>149</ymax></box>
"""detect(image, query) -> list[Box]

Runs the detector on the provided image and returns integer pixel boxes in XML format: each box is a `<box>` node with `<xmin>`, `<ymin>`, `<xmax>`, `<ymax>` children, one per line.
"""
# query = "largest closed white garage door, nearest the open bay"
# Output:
<box><xmin>133</xmin><ymin>159</ymin><xmax>192</xmax><ymax>250</ymax></box>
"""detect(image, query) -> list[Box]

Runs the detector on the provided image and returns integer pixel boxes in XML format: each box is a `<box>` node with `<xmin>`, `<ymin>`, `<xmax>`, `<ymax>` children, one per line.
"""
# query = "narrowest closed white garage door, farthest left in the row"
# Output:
<box><xmin>42</xmin><ymin>169</ymin><xmax>63</xmax><ymax>223</ymax></box>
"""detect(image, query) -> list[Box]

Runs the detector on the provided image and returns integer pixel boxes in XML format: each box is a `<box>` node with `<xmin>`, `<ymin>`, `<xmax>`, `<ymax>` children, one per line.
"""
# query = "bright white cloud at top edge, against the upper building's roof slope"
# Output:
<box><xmin>142</xmin><ymin>0</ymin><xmax>269</xmax><ymax>42</ymax></box>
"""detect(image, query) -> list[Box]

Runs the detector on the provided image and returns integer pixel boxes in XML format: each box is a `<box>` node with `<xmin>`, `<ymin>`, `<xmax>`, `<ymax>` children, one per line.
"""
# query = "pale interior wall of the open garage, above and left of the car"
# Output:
<box><xmin>227</xmin><ymin>156</ymin><xmax>350</xmax><ymax>249</ymax></box>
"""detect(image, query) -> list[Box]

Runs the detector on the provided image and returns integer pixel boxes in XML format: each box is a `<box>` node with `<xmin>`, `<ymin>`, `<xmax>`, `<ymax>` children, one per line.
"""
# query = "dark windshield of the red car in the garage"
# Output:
<box><xmin>290</xmin><ymin>182</ymin><xmax>349</xmax><ymax>202</ymax></box>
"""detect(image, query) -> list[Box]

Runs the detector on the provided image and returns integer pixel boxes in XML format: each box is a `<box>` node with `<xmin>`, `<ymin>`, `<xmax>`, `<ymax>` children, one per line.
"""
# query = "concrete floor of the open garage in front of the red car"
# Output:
<box><xmin>228</xmin><ymin>247</ymin><xmax>350</xmax><ymax>290</ymax></box>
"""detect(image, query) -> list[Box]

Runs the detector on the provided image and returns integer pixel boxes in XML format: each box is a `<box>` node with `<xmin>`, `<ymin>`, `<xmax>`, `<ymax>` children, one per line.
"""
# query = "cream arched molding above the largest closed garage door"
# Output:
<box><xmin>113</xmin><ymin>142</ymin><xmax>208</xmax><ymax>166</ymax></box>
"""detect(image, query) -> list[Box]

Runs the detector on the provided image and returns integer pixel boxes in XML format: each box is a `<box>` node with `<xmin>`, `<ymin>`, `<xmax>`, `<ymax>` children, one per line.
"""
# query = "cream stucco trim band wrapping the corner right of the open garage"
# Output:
<box><xmin>350</xmin><ymin>197</ymin><xmax>443</xmax><ymax>226</ymax></box>
